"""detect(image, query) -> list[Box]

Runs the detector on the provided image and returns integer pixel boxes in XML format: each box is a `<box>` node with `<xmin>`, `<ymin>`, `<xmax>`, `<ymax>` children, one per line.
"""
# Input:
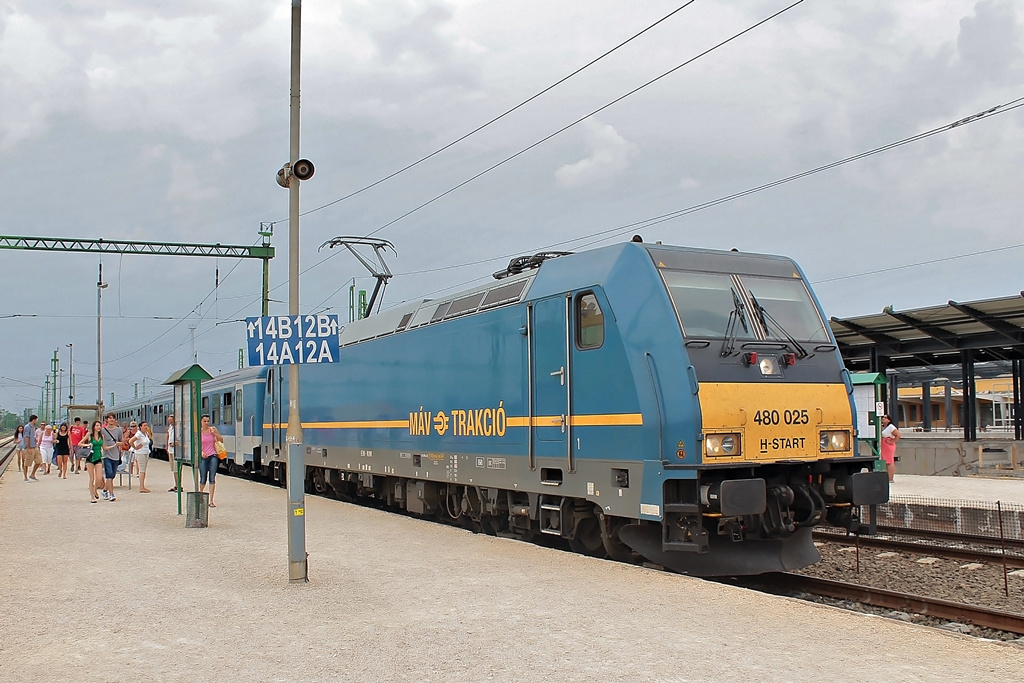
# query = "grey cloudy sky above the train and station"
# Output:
<box><xmin>0</xmin><ymin>0</ymin><xmax>1024</xmax><ymax>411</ymax></box>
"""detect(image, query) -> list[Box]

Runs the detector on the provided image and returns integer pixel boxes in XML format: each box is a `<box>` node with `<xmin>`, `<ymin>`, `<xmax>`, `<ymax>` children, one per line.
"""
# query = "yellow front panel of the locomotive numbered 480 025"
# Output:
<box><xmin>698</xmin><ymin>382</ymin><xmax>855</xmax><ymax>464</ymax></box>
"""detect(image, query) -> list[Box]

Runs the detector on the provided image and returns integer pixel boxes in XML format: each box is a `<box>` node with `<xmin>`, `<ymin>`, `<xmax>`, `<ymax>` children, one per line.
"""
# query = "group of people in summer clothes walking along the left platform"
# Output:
<box><xmin>14</xmin><ymin>413</ymin><xmax>224</xmax><ymax>507</ymax></box>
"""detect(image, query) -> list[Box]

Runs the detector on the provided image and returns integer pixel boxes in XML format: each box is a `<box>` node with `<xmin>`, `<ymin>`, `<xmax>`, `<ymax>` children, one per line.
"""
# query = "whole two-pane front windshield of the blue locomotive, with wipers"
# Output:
<box><xmin>662</xmin><ymin>268</ymin><xmax>828</xmax><ymax>342</ymax></box>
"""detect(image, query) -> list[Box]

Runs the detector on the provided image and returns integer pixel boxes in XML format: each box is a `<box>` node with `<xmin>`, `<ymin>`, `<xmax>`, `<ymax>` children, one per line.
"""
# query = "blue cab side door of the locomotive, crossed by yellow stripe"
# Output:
<box><xmin>529</xmin><ymin>294</ymin><xmax>572</xmax><ymax>475</ymax></box>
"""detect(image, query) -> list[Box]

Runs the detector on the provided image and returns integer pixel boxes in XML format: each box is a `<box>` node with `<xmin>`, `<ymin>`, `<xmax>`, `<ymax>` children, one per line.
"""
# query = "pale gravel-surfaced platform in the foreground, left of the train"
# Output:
<box><xmin>0</xmin><ymin>462</ymin><xmax>1024</xmax><ymax>683</ymax></box>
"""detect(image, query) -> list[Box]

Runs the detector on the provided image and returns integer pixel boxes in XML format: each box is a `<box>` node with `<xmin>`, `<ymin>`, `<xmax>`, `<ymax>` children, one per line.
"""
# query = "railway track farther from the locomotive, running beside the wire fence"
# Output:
<box><xmin>814</xmin><ymin>528</ymin><xmax>1024</xmax><ymax>569</ymax></box>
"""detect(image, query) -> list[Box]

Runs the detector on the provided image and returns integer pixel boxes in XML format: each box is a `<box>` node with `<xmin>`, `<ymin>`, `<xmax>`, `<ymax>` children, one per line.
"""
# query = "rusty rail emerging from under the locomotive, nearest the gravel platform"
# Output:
<box><xmin>742</xmin><ymin>573</ymin><xmax>1024</xmax><ymax>635</ymax></box>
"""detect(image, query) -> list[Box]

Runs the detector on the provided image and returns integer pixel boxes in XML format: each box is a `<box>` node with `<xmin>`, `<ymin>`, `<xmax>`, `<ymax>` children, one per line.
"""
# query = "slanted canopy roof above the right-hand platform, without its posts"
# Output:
<box><xmin>829</xmin><ymin>292</ymin><xmax>1024</xmax><ymax>383</ymax></box>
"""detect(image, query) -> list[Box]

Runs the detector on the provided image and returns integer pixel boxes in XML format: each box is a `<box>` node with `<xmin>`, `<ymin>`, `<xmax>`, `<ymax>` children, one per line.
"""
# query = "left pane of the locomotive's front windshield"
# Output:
<box><xmin>662</xmin><ymin>269</ymin><xmax>755</xmax><ymax>339</ymax></box>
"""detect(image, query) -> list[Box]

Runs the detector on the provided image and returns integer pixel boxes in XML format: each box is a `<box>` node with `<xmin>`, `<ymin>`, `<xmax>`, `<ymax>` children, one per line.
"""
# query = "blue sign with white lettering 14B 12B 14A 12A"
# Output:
<box><xmin>246</xmin><ymin>313</ymin><xmax>340</xmax><ymax>366</ymax></box>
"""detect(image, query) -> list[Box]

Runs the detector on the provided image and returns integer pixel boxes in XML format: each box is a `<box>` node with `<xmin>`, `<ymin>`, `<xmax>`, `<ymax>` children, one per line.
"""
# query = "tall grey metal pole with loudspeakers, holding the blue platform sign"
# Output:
<box><xmin>286</xmin><ymin>0</ymin><xmax>309</xmax><ymax>584</ymax></box>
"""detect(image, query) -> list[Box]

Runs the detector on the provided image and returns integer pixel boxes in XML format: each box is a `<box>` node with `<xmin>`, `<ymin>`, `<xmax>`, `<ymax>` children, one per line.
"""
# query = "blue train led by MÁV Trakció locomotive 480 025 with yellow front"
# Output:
<box><xmin>117</xmin><ymin>242</ymin><xmax>888</xmax><ymax>575</ymax></box>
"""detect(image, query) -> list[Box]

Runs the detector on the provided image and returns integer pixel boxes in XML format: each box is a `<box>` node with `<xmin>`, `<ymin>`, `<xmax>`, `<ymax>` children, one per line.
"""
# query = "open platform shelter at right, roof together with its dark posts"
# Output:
<box><xmin>829</xmin><ymin>292</ymin><xmax>1024</xmax><ymax>441</ymax></box>
